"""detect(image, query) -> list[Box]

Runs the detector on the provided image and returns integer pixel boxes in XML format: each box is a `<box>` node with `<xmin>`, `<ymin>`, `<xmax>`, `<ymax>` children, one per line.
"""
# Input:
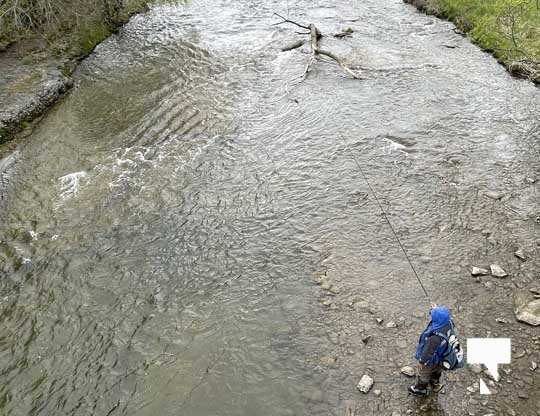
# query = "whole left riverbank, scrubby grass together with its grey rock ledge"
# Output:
<box><xmin>0</xmin><ymin>0</ymin><xmax>153</xmax><ymax>146</ymax></box>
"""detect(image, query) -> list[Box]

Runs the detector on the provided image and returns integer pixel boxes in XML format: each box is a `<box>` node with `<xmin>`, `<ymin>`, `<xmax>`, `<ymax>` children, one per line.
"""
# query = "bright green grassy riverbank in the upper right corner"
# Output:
<box><xmin>403</xmin><ymin>0</ymin><xmax>540</xmax><ymax>84</ymax></box>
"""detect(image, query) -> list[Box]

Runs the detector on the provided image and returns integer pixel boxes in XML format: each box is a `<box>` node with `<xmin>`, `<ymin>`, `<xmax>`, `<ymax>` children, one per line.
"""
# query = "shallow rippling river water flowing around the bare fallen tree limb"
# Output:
<box><xmin>0</xmin><ymin>0</ymin><xmax>540</xmax><ymax>415</ymax></box>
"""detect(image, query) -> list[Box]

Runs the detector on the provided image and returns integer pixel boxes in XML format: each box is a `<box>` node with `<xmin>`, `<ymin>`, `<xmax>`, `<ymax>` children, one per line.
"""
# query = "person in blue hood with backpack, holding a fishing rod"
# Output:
<box><xmin>408</xmin><ymin>304</ymin><xmax>464</xmax><ymax>396</ymax></box>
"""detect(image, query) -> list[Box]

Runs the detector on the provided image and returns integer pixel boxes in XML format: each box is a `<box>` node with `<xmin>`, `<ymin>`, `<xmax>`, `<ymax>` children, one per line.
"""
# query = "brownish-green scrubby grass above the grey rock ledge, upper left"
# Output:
<box><xmin>0</xmin><ymin>0</ymin><xmax>149</xmax><ymax>58</ymax></box>
